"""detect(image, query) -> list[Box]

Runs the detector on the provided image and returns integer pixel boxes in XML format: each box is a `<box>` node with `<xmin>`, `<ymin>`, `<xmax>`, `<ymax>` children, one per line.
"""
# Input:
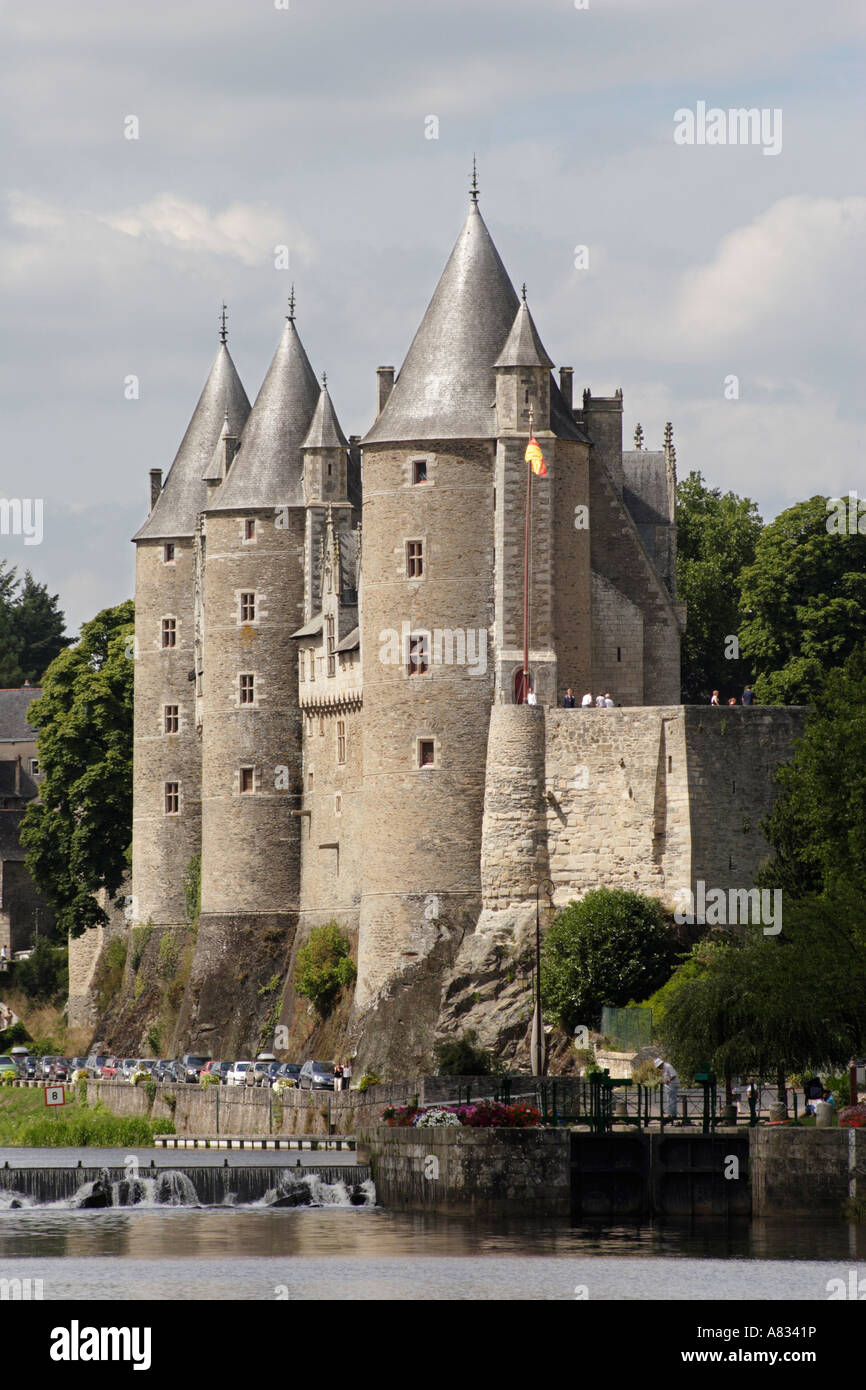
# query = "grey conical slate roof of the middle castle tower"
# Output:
<box><xmin>207</xmin><ymin>318</ymin><xmax>318</xmax><ymax>512</ymax></box>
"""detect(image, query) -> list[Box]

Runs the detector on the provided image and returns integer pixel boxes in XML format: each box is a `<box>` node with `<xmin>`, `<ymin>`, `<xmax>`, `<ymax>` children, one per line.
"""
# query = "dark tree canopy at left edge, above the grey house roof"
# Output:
<box><xmin>0</xmin><ymin>560</ymin><xmax>71</xmax><ymax>688</ymax></box>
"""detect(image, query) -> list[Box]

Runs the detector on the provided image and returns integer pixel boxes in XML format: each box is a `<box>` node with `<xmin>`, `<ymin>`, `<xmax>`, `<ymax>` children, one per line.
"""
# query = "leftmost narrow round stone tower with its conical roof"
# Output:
<box><xmin>132</xmin><ymin>325</ymin><xmax>250</xmax><ymax>926</ymax></box>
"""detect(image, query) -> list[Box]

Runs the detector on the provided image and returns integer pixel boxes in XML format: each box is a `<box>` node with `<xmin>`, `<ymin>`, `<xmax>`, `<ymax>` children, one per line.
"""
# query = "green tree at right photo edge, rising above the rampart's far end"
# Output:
<box><xmin>741</xmin><ymin>496</ymin><xmax>866</xmax><ymax>705</ymax></box>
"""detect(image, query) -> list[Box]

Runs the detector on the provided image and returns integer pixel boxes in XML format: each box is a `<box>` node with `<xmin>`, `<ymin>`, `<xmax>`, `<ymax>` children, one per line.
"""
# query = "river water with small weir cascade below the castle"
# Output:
<box><xmin>0</xmin><ymin>1150</ymin><xmax>866</xmax><ymax>1301</ymax></box>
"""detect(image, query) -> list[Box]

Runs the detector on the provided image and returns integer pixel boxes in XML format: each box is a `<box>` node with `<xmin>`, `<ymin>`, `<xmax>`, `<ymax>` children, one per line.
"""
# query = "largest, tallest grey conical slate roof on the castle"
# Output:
<box><xmin>364</xmin><ymin>203</ymin><xmax>518</xmax><ymax>443</ymax></box>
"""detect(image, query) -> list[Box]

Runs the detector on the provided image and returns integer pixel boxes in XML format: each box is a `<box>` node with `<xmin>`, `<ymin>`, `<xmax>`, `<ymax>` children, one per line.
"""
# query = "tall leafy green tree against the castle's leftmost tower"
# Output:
<box><xmin>21</xmin><ymin>600</ymin><xmax>133</xmax><ymax>935</ymax></box>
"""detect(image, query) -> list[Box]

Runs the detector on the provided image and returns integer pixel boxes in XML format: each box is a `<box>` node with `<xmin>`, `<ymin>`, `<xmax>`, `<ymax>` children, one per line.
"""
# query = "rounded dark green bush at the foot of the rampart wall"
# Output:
<box><xmin>541</xmin><ymin>888</ymin><xmax>677</xmax><ymax>1033</ymax></box>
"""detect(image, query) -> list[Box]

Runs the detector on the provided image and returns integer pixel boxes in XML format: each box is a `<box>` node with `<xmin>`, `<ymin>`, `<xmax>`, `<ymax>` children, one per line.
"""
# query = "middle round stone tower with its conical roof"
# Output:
<box><xmin>199</xmin><ymin>304</ymin><xmax>318</xmax><ymax>955</ymax></box>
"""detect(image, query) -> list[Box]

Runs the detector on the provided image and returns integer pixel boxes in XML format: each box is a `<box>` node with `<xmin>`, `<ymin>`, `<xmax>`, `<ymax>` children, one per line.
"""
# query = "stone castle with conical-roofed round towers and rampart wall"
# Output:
<box><xmin>125</xmin><ymin>188</ymin><xmax>798</xmax><ymax>1066</ymax></box>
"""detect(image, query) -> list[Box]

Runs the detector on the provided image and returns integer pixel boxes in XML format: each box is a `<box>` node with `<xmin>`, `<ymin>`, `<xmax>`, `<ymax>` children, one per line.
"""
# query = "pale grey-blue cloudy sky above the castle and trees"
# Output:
<box><xmin>0</xmin><ymin>0</ymin><xmax>866</xmax><ymax>632</ymax></box>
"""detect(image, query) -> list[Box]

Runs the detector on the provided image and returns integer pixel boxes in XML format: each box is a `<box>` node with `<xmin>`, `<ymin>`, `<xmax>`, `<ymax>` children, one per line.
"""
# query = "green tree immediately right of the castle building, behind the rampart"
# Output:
<box><xmin>677</xmin><ymin>473</ymin><xmax>762</xmax><ymax>705</ymax></box>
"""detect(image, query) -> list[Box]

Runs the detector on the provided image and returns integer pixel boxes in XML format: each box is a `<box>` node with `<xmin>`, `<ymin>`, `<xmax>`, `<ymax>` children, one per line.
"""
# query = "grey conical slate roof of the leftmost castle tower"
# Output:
<box><xmin>132</xmin><ymin>343</ymin><xmax>250</xmax><ymax>541</ymax></box>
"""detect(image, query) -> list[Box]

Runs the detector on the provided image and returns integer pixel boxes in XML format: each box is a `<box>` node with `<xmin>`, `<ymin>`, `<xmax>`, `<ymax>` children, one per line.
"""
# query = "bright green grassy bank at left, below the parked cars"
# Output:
<box><xmin>0</xmin><ymin>1087</ymin><xmax>174</xmax><ymax>1148</ymax></box>
